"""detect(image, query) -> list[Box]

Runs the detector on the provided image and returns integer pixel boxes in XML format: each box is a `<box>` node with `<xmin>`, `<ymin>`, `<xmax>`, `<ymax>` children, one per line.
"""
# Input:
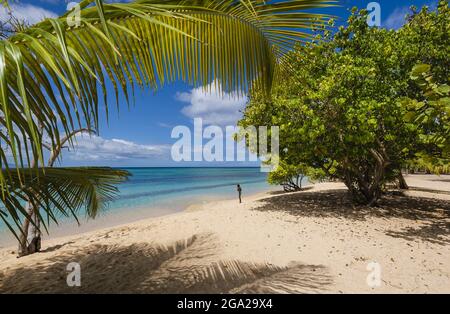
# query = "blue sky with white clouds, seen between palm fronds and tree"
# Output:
<box><xmin>0</xmin><ymin>0</ymin><xmax>437</xmax><ymax>167</ymax></box>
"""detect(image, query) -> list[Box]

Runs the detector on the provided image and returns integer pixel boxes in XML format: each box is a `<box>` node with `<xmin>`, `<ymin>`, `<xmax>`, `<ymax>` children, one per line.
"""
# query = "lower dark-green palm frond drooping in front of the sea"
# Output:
<box><xmin>0</xmin><ymin>167</ymin><xmax>130</xmax><ymax>237</ymax></box>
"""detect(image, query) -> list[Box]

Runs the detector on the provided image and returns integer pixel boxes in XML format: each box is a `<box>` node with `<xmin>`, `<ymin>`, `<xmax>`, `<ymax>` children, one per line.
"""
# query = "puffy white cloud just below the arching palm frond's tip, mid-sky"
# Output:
<box><xmin>176</xmin><ymin>83</ymin><xmax>247</xmax><ymax>126</ymax></box>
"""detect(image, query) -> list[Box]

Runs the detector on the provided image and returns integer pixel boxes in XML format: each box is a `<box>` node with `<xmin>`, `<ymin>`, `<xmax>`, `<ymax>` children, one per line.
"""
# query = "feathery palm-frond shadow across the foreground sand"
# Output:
<box><xmin>0</xmin><ymin>234</ymin><xmax>332</xmax><ymax>293</ymax></box>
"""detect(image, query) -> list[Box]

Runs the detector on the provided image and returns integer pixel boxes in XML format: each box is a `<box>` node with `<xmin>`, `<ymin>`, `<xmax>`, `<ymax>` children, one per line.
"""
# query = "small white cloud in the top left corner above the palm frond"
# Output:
<box><xmin>0</xmin><ymin>3</ymin><xmax>58</xmax><ymax>24</ymax></box>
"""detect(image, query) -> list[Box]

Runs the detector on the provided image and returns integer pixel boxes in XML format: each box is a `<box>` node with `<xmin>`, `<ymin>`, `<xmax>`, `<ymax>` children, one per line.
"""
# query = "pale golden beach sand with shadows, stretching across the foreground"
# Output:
<box><xmin>0</xmin><ymin>175</ymin><xmax>450</xmax><ymax>293</ymax></box>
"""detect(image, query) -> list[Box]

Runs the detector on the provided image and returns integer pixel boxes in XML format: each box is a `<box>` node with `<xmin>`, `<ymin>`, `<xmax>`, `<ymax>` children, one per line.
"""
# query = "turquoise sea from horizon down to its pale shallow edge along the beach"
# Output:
<box><xmin>0</xmin><ymin>168</ymin><xmax>277</xmax><ymax>246</ymax></box>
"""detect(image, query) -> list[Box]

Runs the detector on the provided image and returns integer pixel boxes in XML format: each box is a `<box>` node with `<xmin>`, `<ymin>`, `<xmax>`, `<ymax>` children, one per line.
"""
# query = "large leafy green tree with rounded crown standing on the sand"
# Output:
<box><xmin>240</xmin><ymin>1</ymin><xmax>450</xmax><ymax>205</ymax></box>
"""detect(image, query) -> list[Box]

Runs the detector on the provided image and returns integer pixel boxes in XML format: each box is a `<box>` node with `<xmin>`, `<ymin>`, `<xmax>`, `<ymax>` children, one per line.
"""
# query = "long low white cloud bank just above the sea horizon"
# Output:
<box><xmin>63</xmin><ymin>134</ymin><xmax>170</xmax><ymax>161</ymax></box>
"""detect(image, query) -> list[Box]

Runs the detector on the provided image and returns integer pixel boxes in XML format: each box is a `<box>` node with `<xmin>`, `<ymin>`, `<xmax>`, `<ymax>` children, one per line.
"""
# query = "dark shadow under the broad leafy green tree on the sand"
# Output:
<box><xmin>251</xmin><ymin>189</ymin><xmax>450</xmax><ymax>245</ymax></box>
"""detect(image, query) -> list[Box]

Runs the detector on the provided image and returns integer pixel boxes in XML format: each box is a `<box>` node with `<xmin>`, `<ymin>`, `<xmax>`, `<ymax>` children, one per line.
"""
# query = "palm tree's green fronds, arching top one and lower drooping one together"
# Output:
<box><xmin>0</xmin><ymin>0</ymin><xmax>335</xmax><ymax>247</ymax></box>
